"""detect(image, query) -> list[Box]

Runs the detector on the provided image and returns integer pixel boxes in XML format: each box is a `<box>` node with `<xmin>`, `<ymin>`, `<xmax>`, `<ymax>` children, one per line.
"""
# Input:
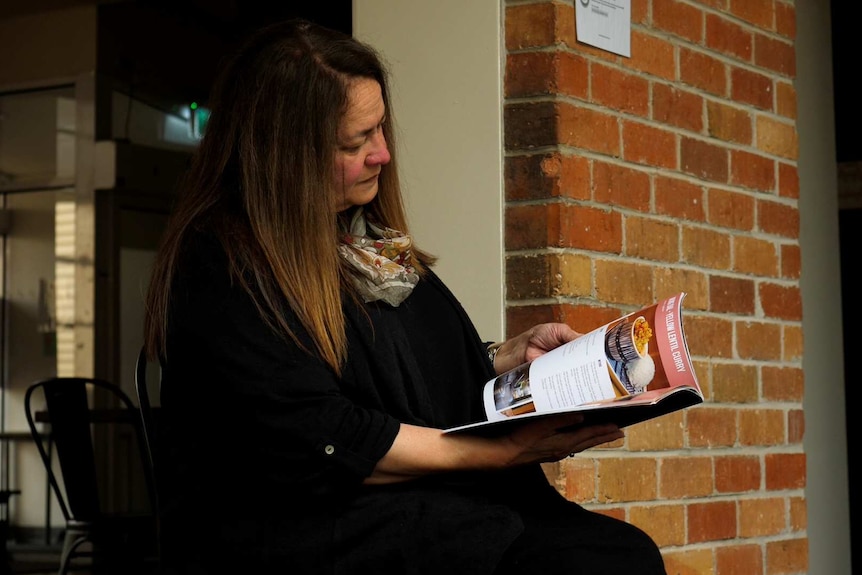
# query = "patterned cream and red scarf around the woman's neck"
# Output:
<box><xmin>338</xmin><ymin>207</ymin><xmax>419</xmax><ymax>307</ymax></box>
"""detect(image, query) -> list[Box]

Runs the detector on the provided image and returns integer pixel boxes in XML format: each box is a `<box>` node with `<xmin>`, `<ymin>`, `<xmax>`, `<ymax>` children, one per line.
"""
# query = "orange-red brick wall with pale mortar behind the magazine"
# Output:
<box><xmin>504</xmin><ymin>0</ymin><xmax>808</xmax><ymax>575</ymax></box>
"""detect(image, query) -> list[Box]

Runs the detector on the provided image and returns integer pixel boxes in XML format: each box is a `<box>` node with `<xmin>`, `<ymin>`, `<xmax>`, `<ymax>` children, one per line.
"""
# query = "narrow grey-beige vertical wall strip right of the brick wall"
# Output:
<box><xmin>796</xmin><ymin>0</ymin><xmax>850</xmax><ymax>575</ymax></box>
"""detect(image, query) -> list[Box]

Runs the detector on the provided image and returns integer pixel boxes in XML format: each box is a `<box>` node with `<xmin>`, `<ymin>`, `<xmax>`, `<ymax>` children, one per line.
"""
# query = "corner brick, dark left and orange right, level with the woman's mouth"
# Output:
<box><xmin>504</xmin><ymin>152</ymin><xmax>590</xmax><ymax>201</ymax></box>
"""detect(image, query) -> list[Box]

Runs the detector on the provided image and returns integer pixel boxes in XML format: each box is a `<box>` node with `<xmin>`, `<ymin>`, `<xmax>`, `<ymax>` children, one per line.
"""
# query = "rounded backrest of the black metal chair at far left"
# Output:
<box><xmin>24</xmin><ymin>377</ymin><xmax>155</xmax><ymax>522</ymax></box>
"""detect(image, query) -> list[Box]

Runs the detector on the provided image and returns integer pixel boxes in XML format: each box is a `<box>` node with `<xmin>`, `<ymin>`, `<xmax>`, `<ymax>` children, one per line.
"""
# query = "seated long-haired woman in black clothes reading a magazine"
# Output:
<box><xmin>146</xmin><ymin>21</ymin><xmax>664</xmax><ymax>574</ymax></box>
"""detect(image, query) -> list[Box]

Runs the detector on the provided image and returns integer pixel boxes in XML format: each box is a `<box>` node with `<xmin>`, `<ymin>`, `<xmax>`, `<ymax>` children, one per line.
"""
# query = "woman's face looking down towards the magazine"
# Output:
<box><xmin>334</xmin><ymin>78</ymin><xmax>390</xmax><ymax>211</ymax></box>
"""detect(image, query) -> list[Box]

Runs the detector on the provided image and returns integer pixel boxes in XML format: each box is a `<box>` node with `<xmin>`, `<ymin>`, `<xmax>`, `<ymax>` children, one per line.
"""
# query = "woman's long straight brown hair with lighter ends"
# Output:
<box><xmin>144</xmin><ymin>20</ymin><xmax>434</xmax><ymax>373</ymax></box>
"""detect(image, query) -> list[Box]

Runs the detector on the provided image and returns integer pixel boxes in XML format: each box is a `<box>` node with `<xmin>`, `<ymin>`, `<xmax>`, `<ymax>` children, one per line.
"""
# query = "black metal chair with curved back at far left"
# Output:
<box><xmin>24</xmin><ymin>377</ymin><xmax>158</xmax><ymax>575</ymax></box>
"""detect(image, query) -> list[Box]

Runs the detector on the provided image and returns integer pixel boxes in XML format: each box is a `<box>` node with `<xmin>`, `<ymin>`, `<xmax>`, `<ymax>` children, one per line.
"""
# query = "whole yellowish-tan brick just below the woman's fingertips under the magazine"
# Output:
<box><xmin>599</xmin><ymin>457</ymin><xmax>657</xmax><ymax>502</ymax></box>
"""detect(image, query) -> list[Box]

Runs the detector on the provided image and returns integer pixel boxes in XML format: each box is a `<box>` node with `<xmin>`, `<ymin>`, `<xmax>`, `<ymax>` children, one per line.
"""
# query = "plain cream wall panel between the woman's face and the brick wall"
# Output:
<box><xmin>353</xmin><ymin>0</ymin><xmax>504</xmax><ymax>340</ymax></box>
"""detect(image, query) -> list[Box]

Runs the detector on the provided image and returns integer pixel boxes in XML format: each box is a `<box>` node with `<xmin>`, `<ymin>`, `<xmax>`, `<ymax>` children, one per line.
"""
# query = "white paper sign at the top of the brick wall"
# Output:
<box><xmin>575</xmin><ymin>0</ymin><xmax>632</xmax><ymax>57</ymax></box>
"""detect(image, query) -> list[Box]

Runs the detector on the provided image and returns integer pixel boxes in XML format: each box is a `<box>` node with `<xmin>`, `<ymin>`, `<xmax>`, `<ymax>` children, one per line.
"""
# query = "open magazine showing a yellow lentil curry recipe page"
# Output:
<box><xmin>447</xmin><ymin>292</ymin><xmax>703</xmax><ymax>434</ymax></box>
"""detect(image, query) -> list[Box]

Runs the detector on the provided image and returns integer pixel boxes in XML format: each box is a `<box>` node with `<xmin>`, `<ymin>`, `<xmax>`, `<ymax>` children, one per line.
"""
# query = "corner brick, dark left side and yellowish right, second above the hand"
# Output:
<box><xmin>506</xmin><ymin>254</ymin><xmax>591</xmax><ymax>300</ymax></box>
